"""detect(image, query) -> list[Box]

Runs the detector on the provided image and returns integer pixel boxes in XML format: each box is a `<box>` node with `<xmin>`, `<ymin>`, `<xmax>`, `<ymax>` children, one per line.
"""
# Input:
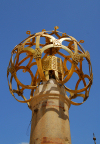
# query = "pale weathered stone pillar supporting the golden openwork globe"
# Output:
<box><xmin>30</xmin><ymin>79</ymin><xmax>71</xmax><ymax>144</ymax></box>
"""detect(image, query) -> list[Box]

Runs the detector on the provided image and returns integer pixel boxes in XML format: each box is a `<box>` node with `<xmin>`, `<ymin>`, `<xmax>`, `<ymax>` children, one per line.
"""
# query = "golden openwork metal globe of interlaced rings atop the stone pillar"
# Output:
<box><xmin>7</xmin><ymin>26</ymin><xmax>93</xmax><ymax>105</ymax></box>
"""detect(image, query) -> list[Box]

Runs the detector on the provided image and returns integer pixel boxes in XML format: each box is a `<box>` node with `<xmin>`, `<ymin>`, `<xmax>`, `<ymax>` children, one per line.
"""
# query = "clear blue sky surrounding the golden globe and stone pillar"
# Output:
<box><xmin>0</xmin><ymin>0</ymin><xmax>100</xmax><ymax>144</ymax></box>
